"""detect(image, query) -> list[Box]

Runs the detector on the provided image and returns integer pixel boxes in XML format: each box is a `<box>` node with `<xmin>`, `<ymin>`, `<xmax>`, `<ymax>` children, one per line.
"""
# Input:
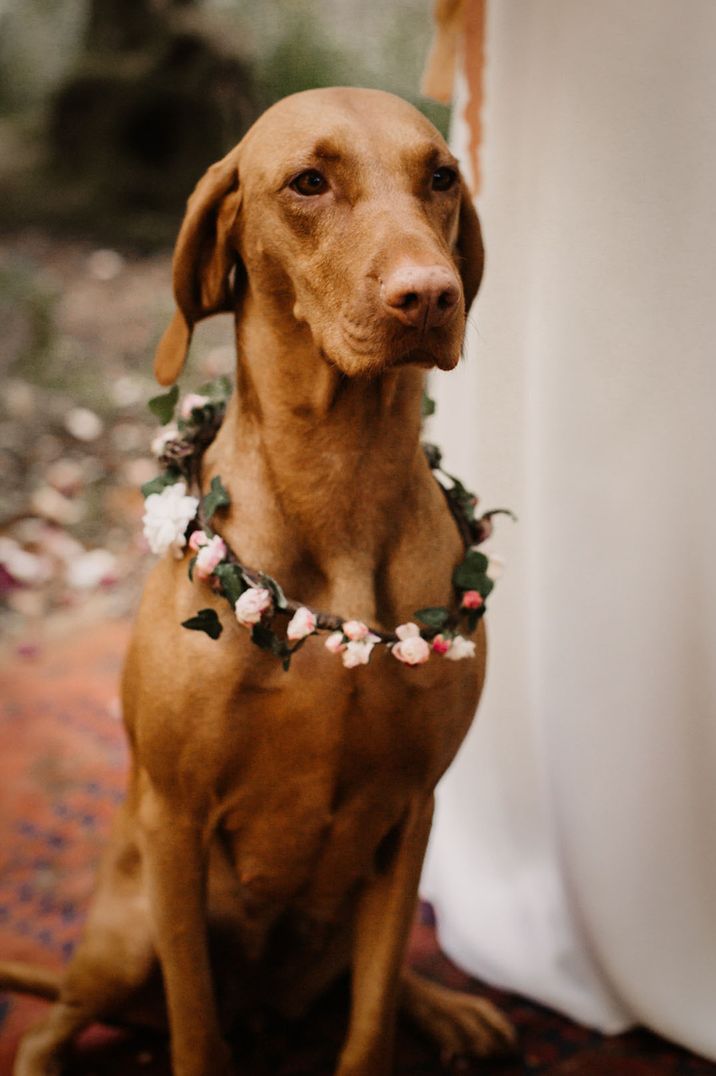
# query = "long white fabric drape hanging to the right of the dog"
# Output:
<box><xmin>423</xmin><ymin>0</ymin><xmax>716</xmax><ymax>1059</ymax></box>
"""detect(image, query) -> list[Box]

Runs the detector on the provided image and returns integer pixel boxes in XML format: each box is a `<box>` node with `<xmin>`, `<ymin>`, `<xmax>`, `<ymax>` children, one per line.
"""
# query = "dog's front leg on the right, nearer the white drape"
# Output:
<box><xmin>336</xmin><ymin>796</ymin><xmax>433</xmax><ymax>1076</ymax></box>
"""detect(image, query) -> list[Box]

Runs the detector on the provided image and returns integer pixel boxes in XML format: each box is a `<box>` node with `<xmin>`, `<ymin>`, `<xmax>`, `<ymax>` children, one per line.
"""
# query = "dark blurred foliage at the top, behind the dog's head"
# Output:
<box><xmin>0</xmin><ymin>0</ymin><xmax>447</xmax><ymax>246</ymax></box>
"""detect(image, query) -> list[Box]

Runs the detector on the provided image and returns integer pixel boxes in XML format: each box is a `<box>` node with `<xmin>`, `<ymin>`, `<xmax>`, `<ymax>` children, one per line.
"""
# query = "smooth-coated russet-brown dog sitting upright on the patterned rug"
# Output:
<box><xmin>4</xmin><ymin>89</ymin><xmax>513</xmax><ymax>1076</ymax></box>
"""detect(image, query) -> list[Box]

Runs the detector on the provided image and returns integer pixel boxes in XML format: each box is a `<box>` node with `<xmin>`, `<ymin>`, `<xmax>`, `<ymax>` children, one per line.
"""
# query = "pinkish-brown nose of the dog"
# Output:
<box><xmin>381</xmin><ymin>265</ymin><xmax>460</xmax><ymax>331</ymax></box>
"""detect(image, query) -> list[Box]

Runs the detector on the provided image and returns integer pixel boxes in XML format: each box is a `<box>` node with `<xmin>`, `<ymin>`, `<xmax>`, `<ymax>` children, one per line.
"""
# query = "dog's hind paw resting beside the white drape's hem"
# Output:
<box><xmin>403</xmin><ymin>972</ymin><xmax>517</xmax><ymax>1071</ymax></box>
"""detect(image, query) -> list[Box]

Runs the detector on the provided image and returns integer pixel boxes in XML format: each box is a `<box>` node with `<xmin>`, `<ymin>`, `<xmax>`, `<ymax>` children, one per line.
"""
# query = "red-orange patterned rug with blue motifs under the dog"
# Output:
<box><xmin>0</xmin><ymin>623</ymin><xmax>716</xmax><ymax>1076</ymax></box>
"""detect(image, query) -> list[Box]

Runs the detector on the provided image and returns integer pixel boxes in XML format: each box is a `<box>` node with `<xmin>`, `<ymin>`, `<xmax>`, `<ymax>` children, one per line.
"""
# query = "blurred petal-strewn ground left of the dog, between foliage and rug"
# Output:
<box><xmin>0</xmin><ymin>232</ymin><xmax>234</xmax><ymax>653</ymax></box>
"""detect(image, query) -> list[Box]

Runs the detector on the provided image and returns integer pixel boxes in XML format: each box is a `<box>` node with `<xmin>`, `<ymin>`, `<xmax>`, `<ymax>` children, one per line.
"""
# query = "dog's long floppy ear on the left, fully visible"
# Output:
<box><xmin>154</xmin><ymin>146</ymin><xmax>241</xmax><ymax>385</ymax></box>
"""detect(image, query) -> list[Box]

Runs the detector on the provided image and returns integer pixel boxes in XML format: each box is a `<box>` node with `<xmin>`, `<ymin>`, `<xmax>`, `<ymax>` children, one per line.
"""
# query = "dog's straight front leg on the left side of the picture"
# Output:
<box><xmin>141</xmin><ymin>788</ymin><xmax>231</xmax><ymax>1076</ymax></box>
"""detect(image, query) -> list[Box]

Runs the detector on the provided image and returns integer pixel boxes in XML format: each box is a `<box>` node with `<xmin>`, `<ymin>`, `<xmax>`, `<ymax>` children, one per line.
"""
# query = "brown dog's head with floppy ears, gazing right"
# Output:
<box><xmin>155</xmin><ymin>88</ymin><xmax>483</xmax><ymax>384</ymax></box>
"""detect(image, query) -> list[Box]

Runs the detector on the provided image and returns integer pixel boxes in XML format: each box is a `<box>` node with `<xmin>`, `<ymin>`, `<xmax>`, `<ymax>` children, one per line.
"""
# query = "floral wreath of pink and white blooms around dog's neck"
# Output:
<box><xmin>142</xmin><ymin>378</ymin><xmax>514</xmax><ymax>670</ymax></box>
